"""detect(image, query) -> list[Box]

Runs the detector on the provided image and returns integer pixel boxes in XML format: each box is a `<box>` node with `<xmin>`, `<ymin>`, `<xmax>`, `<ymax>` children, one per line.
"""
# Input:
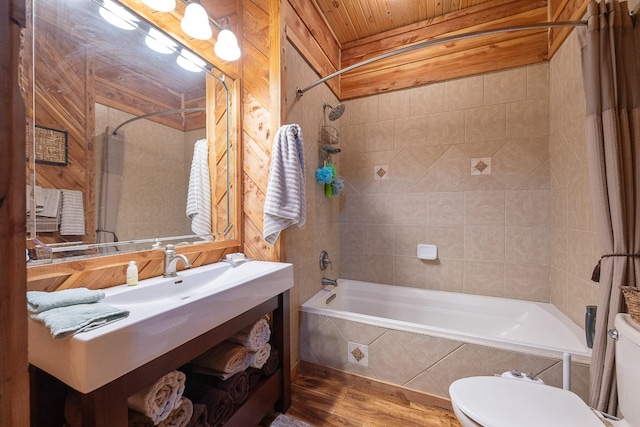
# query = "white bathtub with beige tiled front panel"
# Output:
<box><xmin>300</xmin><ymin>280</ymin><xmax>589</xmax><ymax>399</ymax></box>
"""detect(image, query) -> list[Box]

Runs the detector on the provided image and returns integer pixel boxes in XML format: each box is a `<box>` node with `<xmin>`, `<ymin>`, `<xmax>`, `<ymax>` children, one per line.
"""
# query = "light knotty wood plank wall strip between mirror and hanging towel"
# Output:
<box><xmin>241</xmin><ymin>0</ymin><xmax>282</xmax><ymax>261</ymax></box>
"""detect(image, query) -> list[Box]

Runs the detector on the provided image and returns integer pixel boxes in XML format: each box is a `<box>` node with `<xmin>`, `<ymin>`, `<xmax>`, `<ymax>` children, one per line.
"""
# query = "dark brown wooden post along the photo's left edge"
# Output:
<box><xmin>0</xmin><ymin>0</ymin><xmax>29</xmax><ymax>426</ymax></box>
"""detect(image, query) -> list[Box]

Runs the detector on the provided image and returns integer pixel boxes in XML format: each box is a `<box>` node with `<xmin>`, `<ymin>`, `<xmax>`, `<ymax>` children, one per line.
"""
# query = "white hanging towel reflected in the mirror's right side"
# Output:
<box><xmin>187</xmin><ymin>139</ymin><xmax>211</xmax><ymax>234</ymax></box>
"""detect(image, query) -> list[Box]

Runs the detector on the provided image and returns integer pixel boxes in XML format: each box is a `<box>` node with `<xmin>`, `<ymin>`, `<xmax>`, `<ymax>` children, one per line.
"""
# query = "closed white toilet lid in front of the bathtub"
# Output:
<box><xmin>449</xmin><ymin>377</ymin><xmax>603</xmax><ymax>427</ymax></box>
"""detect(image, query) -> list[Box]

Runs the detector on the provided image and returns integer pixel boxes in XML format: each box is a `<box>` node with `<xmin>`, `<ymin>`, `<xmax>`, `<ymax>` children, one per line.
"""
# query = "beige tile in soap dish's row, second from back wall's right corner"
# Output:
<box><xmin>464</xmin><ymin>226</ymin><xmax>505</xmax><ymax>262</ymax></box>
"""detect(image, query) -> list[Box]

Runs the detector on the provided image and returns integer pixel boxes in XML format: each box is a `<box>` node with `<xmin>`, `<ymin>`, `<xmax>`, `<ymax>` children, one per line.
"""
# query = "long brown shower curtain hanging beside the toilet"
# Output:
<box><xmin>579</xmin><ymin>0</ymin><xmax>640</xmax><ymax>414</ymax></box>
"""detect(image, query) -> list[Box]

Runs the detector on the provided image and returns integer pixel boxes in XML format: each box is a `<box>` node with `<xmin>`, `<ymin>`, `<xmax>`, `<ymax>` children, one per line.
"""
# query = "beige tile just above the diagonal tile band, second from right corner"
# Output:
<box><xmin>464</xmin><ymin>104</ymin><xmax>504</xmax><ymax>142</ymax></box>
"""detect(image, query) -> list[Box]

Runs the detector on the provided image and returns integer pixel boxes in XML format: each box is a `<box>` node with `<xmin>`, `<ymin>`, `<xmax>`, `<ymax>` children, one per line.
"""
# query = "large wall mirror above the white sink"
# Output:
<box><xmin>25</xmin><ymin>0</ymin><xmax>235</xmax><ymax>265</ymax></box>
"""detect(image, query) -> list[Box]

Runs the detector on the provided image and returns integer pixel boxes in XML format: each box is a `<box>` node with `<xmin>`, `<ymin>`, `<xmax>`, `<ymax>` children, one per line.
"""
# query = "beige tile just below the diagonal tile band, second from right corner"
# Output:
<box><xmin>464</xmin><ymin>191</ymin><xmax>505</xmax><ymax>226</ymax></box>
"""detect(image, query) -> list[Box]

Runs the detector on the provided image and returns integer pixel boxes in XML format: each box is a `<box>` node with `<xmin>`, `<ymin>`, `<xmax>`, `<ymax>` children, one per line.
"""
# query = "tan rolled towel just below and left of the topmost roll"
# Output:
<box><xmin>193</xmin><ymin>341</ymin><xmax>249</xmax><ymax>375</ymax></box>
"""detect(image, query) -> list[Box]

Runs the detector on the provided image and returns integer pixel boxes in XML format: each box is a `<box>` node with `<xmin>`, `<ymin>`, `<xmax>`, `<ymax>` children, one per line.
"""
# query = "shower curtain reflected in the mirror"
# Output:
<box><xmin>96</xmin><ymin>126</ymin><xmax>124</xmax><ymax>252</ymax></box>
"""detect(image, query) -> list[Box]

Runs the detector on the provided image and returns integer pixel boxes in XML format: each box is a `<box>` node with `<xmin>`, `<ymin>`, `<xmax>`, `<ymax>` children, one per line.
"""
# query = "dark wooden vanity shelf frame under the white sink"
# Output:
<box><xmin>29</xmin><ymin>290</ymin><xmax>291</xmax><ymax>427</ymax></box>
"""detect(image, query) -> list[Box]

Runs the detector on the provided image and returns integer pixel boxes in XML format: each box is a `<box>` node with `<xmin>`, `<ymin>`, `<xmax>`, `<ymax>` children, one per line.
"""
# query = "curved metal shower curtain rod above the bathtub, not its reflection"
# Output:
<box><xmin>296</xmin><ymin>21</ymin><xmax>587</xmax><ymax>99</ymax></box>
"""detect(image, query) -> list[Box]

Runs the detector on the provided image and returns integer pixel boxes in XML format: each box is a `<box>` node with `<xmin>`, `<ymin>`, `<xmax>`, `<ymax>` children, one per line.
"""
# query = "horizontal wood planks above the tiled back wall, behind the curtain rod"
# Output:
<box><xmin>340</xmin><ymin>0</ymin><xmax>548</xmax><ymax>100</ymax></box>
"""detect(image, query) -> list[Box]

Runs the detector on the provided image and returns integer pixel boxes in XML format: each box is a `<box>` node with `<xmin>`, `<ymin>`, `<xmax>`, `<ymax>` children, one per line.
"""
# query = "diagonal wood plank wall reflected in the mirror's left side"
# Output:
<box><xmin>27</xmin><ymin>21</ymin><xmax>96</xmax><ymax>243</ymax></box>
